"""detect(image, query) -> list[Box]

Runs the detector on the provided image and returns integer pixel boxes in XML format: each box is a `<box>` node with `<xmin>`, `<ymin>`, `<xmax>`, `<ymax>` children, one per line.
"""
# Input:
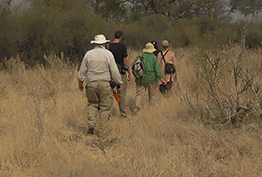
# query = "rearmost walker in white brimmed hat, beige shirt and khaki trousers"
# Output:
<box><xmin>78</xmin><ymin>34</ymin><xmax>123</xmax><ymax>134</ymax></box>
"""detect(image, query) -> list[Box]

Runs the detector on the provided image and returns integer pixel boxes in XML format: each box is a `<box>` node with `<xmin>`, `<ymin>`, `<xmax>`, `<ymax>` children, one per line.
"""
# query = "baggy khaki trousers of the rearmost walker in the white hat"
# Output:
<box><xmin>86</xmin><ymin>81</ymin><xmax>114</xmax><ymax>128</ymax></box>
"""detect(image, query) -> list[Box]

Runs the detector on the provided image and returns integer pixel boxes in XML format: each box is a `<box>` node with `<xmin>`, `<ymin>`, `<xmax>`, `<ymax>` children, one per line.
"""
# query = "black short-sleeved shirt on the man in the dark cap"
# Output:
<box><xmin>108</xmin><ymin>43</ymin><xmax>128</xmax><ymax>66</ymax></box>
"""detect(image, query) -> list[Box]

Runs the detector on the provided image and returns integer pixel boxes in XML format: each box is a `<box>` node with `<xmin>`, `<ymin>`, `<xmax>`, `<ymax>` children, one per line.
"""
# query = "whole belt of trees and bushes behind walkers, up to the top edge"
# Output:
<box><xmin>0</xmin><ymin>0</ymin><xmax>262</xmax><ymax>65</ymax></box>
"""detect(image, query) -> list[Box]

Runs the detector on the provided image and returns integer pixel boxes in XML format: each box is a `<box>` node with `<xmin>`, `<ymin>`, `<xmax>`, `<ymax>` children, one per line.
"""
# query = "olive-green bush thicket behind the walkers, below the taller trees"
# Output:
<box><xmin>0</xmin><ymin>0</ymin><xmax>262</xmax><ymax>65</ymax></box>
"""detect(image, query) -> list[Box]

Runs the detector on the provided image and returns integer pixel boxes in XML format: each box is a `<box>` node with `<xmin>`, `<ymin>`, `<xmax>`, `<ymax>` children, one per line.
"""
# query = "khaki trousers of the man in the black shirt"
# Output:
<box><xmin>117</xmin><ymin>74</ymin><xmax>128</xmax><ymax>117</ymax></box>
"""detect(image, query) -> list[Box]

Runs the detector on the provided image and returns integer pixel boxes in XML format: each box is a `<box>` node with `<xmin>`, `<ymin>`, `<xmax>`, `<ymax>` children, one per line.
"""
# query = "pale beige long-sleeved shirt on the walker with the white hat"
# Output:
<box><xmin>78</xmin><ymin>45</ymin><xmax>123</xmax><ymax>85</ymax></box>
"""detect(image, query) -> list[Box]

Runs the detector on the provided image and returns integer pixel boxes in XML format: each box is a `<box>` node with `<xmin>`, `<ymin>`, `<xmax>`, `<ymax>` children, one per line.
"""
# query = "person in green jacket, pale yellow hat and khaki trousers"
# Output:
<box><xmin>133</xmin><ymin>42</ymin><xmax>166</xmax><ymax>113</ymax></box>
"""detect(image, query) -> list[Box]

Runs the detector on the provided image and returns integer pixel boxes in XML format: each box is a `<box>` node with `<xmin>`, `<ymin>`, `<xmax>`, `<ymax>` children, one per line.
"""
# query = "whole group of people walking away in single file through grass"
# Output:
<box><xmin>78</xmin><ymin>30</ymin><xmax>177</xmax><ymax>134</ymax></box>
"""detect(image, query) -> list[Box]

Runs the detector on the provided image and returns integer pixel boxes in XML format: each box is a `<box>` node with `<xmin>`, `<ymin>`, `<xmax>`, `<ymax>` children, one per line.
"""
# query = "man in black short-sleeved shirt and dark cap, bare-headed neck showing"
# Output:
<box><xmin>108</xmin><ymin>30</ymin><xmax>131</xmax><ymax>118</ymax></box>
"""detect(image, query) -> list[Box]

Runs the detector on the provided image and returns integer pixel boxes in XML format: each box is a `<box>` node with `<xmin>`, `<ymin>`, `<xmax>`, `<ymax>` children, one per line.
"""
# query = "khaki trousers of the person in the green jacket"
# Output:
<box><xmin>135</xmin><ymin>82</ymin><xmax>158</xmax><ymax>108</ymax></box>
